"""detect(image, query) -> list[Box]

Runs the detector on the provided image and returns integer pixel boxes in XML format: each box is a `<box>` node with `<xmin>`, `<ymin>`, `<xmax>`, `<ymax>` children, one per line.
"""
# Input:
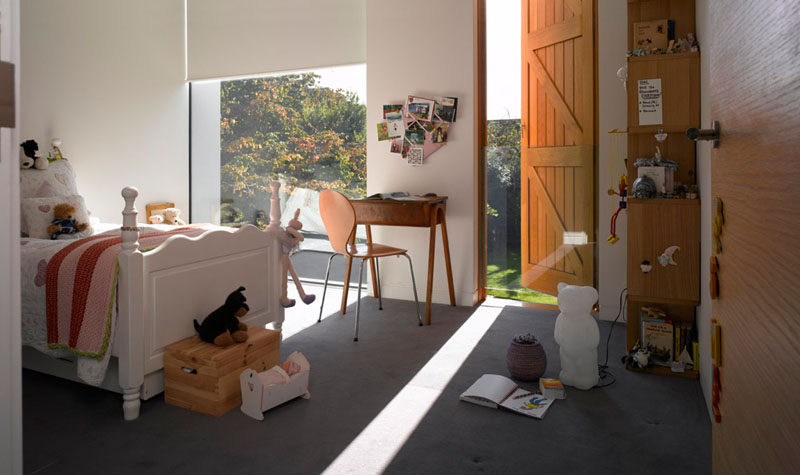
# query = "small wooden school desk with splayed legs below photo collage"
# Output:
<box><xmin>341</xmin><ymin>196</ymin><xmax>456</xmax><ymax>325</ymax></box>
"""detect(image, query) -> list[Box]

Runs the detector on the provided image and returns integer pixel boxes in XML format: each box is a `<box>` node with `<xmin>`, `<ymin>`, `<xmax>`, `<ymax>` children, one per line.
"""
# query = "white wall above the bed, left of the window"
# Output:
<box><xmin>20</xmin><ymin>0</ymin><xmax>189</xmax><ymax>222</ymax></box>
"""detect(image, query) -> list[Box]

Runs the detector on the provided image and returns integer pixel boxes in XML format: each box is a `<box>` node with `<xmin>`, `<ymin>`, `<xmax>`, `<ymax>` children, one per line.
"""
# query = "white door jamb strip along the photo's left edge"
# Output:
<box><xmin>0</xmin><ymin>0</ymin><xmax>22</xmax><ymax>474</ymax></box>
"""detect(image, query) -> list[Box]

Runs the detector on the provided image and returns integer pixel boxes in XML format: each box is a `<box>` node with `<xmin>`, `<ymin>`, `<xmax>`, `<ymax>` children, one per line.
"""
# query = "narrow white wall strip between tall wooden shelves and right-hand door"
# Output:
<box><xmin>695</xmin><ymin>0</ymin><xmax>713</xmax><ymax>417</ymax></box>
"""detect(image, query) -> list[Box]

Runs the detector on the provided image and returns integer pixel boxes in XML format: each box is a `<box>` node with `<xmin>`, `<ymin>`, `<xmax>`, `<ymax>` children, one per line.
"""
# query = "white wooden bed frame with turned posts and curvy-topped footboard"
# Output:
<box><xmin>23</xmin><ymin>187</ymin><xmax>284</xmax><ymax>420</ymax></box>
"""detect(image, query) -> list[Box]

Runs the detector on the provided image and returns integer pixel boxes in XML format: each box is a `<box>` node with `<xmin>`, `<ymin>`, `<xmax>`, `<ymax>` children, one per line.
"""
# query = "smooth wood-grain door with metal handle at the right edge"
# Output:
<box><xmin>700</xmin><ymin>0</ymin><xmax>800</xmax><ymax>474</ymax></box>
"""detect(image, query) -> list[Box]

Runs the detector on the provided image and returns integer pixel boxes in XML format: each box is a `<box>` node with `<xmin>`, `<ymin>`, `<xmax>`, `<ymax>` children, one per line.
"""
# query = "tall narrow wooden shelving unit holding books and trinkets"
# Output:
<box><xmin>626</xmin><ymin>0</ymin><xmax>702</xmax><ymax>378</ymax></box>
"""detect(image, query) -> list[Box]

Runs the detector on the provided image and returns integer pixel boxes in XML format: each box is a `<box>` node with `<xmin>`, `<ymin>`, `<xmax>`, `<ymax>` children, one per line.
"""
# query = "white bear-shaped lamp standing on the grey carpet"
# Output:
<box><xmin>554</xmin><ymin>282</ymin><xmax>600</xmax><ymax>389</ymax></box>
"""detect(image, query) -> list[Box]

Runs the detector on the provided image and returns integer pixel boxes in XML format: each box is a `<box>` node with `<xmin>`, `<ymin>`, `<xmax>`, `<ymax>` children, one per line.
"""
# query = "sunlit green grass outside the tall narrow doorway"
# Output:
<box><xmin>486</xmin><ymin>251</ymin><xmax>558</xmax><ymax>305</ymax></box>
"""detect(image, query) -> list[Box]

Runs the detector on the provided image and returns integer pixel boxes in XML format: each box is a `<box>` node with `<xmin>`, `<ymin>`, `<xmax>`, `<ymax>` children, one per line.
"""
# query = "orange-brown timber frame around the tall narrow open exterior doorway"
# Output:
<box><xmin>472</xmin><ymin>0</ymin><xmax>600</xmax><ymax>309</ymax></box>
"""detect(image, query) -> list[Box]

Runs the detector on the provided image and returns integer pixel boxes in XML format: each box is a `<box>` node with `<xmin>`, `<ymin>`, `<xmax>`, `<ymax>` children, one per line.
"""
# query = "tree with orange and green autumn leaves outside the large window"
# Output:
<box><xmin>220</xmin><ymin>73</ymin><xmax>367</xmax><ymax>223</ymax></box>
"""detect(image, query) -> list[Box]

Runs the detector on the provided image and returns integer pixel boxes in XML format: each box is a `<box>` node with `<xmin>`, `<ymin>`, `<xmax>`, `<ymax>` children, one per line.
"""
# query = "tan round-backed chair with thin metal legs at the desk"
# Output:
<box><xmin>317</xmin><ymin>190</ymin><xmax>422</xmax><ymax>341</ymax></box>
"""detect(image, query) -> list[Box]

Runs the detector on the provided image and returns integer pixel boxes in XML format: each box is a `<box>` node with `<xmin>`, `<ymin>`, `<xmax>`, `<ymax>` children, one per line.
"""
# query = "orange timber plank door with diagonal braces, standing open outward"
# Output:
<box><xmin>520</xmin><ymin>0</ymin><xmax>597</xmax><ymax>295</ymax></box>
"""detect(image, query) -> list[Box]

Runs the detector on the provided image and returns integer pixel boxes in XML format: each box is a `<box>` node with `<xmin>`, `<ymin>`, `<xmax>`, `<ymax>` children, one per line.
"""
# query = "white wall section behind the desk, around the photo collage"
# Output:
<box><xmin>367</xmin><ymin>0</ymin><xmax>477</xmax><ymax>306</ymax></box>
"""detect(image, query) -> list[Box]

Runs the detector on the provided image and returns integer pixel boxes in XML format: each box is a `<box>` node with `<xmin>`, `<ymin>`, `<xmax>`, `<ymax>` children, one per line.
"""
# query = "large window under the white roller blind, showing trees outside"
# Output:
<box><xmin>191</xmin><ymin>65</ymin><xmax>366</xmax><ymax>278</ymax></box>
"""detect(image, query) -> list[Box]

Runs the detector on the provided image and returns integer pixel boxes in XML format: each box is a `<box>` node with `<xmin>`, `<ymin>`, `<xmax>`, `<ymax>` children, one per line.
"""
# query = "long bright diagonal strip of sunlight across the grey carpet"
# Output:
<box><xmin>323</xmin><ymin>304</ymin><xmax>502</xmax><ymax>474</ymax></box>
